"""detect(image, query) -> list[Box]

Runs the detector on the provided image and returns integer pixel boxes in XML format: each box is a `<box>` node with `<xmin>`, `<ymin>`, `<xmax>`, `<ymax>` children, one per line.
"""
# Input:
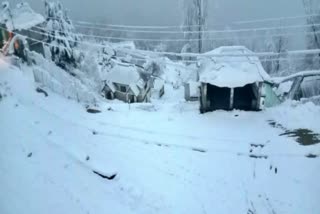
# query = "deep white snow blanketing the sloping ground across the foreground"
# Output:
<box><xmin>0</xmin><ymin>60</ymin><xmax>320</xmax><ymax>214</ymax></box>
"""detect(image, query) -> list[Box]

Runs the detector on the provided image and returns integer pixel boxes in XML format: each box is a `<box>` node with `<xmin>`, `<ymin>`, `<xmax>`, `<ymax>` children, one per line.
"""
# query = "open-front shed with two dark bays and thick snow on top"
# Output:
<box><xmin>199</xmin><ymin>46</ymin><xmax>270</xmax><ymax>113</ymax></box>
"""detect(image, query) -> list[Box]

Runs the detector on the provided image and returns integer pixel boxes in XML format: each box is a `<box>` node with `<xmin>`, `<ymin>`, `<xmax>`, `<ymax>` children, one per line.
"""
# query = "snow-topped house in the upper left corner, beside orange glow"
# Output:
<box><xmin>0</xmin><ymin>2</ymin><xmax>45</xmax><ymax>55</ymax></box>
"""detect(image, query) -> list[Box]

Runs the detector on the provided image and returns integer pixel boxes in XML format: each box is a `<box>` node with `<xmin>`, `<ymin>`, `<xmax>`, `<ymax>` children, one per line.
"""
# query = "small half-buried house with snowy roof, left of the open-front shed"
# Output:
<box><xmin>103</xmin><ymin>63</ymin><xmax>151</xmax><ymax>103</ymax></box>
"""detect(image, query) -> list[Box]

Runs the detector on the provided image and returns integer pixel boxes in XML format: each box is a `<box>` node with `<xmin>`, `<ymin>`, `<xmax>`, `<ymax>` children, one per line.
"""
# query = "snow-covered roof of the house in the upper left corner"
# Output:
<box><xmin>0</xmin><ymin>2</ymin><xmax>45</xmax><ymax>31</ymax></box>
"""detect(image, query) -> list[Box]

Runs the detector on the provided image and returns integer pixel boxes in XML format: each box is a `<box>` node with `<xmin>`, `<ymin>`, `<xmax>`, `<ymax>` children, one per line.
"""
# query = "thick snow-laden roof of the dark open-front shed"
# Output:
<box><xmin>199</xmin><ymin>46</ymin><xmax>270</xmax><ymax>88</ymax></box>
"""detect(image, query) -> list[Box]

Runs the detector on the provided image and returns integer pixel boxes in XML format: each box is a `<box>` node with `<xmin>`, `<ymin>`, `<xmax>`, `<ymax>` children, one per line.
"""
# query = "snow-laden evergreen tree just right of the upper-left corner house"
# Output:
<box><xmin>45</xmin><ymin>1</ymin><xmax>80</xmax><ymax>69</ymax></box>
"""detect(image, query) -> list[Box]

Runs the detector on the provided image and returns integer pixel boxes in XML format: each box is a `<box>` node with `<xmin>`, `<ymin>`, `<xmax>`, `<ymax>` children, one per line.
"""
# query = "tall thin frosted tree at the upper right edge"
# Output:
<box><xmin>303</xmin><ymin>0</ymin><xmax>320</xmax><ymax>69</ymax></box>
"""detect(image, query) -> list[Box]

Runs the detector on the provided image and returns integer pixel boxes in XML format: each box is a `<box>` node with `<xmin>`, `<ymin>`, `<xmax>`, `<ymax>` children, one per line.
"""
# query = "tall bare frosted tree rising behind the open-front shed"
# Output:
<box><xmin>182</xmin><ymin>0</ymin><xmax>208</xmax><ymax>53</ymax></box>
